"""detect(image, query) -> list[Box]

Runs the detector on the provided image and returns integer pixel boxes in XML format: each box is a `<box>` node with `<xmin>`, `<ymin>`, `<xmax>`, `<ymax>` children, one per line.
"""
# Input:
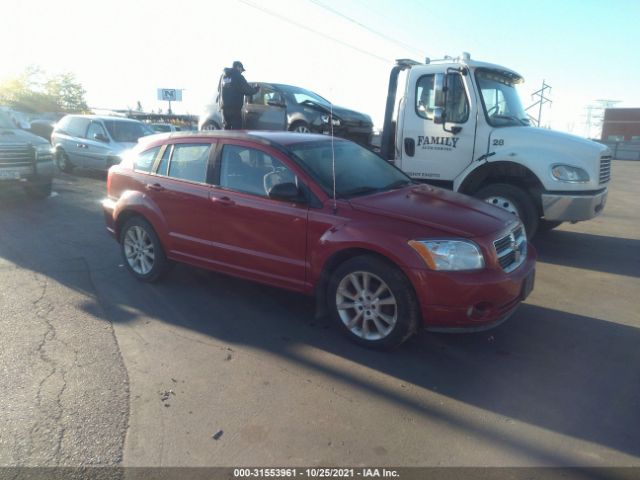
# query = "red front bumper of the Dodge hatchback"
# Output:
<box><xmin>411</xmin><ymin>248</ymin><xmax>536</xmax><ymax>332</ymax></box>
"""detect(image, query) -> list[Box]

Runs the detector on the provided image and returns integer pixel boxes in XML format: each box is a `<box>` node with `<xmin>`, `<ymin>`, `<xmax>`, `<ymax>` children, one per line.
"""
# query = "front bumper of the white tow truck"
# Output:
<box><xmin>542</xmin><ymin>188</ymin><xmax>608</xmax><ymax>222</ymax></box>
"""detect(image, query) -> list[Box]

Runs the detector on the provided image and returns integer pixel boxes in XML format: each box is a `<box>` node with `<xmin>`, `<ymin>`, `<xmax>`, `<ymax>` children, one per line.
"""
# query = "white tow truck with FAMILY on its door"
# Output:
<box><xmin>380</xmin><ymin>53</ymin><xmax>611</xmax><ymax>238</ymax></box>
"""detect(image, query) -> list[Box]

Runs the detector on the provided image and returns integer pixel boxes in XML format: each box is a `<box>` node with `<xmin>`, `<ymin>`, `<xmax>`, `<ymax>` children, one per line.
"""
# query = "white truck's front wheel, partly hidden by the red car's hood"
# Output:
<box><xmin>474</xmin><ymin>183</ymin><xmax>540</xmax><ymax>239</ymax></box>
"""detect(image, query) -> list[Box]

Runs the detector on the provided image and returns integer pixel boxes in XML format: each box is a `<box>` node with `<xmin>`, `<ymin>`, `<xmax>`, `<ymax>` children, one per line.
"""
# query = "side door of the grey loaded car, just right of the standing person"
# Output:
<box><xmin>242</xmin><ymin>85</ymin><xmax>287</xmax><ymax>130</ymax></box>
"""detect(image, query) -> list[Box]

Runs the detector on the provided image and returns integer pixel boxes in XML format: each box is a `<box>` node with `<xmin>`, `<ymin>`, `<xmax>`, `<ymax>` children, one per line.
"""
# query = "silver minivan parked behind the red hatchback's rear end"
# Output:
<box><xmin>51</xmin><ymin>115</ymin><xmax>156</xmax><ymax>172</ymax></box>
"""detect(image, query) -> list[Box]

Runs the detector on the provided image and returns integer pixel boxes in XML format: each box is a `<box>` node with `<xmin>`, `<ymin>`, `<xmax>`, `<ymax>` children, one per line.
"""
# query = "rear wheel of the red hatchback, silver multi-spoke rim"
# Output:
<box><xmin>120</xmin><ymin>217</ymin><xmax>168</xmax><ymax>283</ymax></box>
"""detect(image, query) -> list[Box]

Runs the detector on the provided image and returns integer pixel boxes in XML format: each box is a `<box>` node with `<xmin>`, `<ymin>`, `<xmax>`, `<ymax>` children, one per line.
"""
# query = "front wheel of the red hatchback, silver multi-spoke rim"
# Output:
<box><xmin>327</xmin><ymin>255</ymin><xmax>420</xmax><ymax>350</ymax></box>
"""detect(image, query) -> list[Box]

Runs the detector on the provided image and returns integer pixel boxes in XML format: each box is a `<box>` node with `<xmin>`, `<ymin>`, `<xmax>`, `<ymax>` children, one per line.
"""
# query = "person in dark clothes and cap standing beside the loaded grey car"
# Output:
<box><xmin>218</xmin><ymin>60</ymin><xmax>260</xmax><ymax>130</ymax></box>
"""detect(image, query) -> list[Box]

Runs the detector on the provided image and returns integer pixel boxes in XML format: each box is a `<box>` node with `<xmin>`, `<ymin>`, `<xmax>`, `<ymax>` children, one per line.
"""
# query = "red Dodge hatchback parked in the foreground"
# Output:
<box><xmin>103</xmin><ymin>132</ymin><xmax>536</xmax><ymax>348</ymax></box>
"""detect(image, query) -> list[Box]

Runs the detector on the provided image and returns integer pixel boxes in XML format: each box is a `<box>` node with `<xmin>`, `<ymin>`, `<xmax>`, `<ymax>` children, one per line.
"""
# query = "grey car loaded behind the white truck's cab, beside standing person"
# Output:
<box><xmin>199</xmin><ymin>82</ymin><xmax>373</xmax><ymax>145</ymax></box>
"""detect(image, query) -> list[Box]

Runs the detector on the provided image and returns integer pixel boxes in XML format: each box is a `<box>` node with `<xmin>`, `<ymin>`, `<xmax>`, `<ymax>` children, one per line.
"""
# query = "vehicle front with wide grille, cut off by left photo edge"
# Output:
<box><xmin>0</xmin><ymin>111</ymin><xmax>54</xmax><ymax>198</ymax></box>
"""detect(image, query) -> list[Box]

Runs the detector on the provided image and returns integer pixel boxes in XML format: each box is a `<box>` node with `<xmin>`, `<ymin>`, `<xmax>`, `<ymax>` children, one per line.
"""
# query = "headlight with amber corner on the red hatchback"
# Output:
<box><xmin>409</xmin><ymin>240</ymin><xmax>484</xmax><ymax>271</ymax></box>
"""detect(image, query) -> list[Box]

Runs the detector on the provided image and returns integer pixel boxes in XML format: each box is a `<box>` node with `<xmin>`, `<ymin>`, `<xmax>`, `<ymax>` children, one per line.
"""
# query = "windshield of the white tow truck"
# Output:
<box><xmin>476</xmin><ymin>69</ymin><xmax>529</xmax><ymax>127</ymax></box>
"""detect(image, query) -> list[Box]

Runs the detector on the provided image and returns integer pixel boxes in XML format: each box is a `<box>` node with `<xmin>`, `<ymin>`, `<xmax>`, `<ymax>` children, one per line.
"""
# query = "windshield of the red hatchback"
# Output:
<box><xmin>289</xmin><ymin>140</ymin><xmax>413</xmax><ymax>198</ymax></box>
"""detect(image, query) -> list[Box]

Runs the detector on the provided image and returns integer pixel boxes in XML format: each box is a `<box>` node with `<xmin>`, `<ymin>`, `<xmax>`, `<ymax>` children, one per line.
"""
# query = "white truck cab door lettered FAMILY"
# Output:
<box><xmin>397</xmin><ymin>68</ymin><xmax>475</xmax><ymax>187</ymax></box>
